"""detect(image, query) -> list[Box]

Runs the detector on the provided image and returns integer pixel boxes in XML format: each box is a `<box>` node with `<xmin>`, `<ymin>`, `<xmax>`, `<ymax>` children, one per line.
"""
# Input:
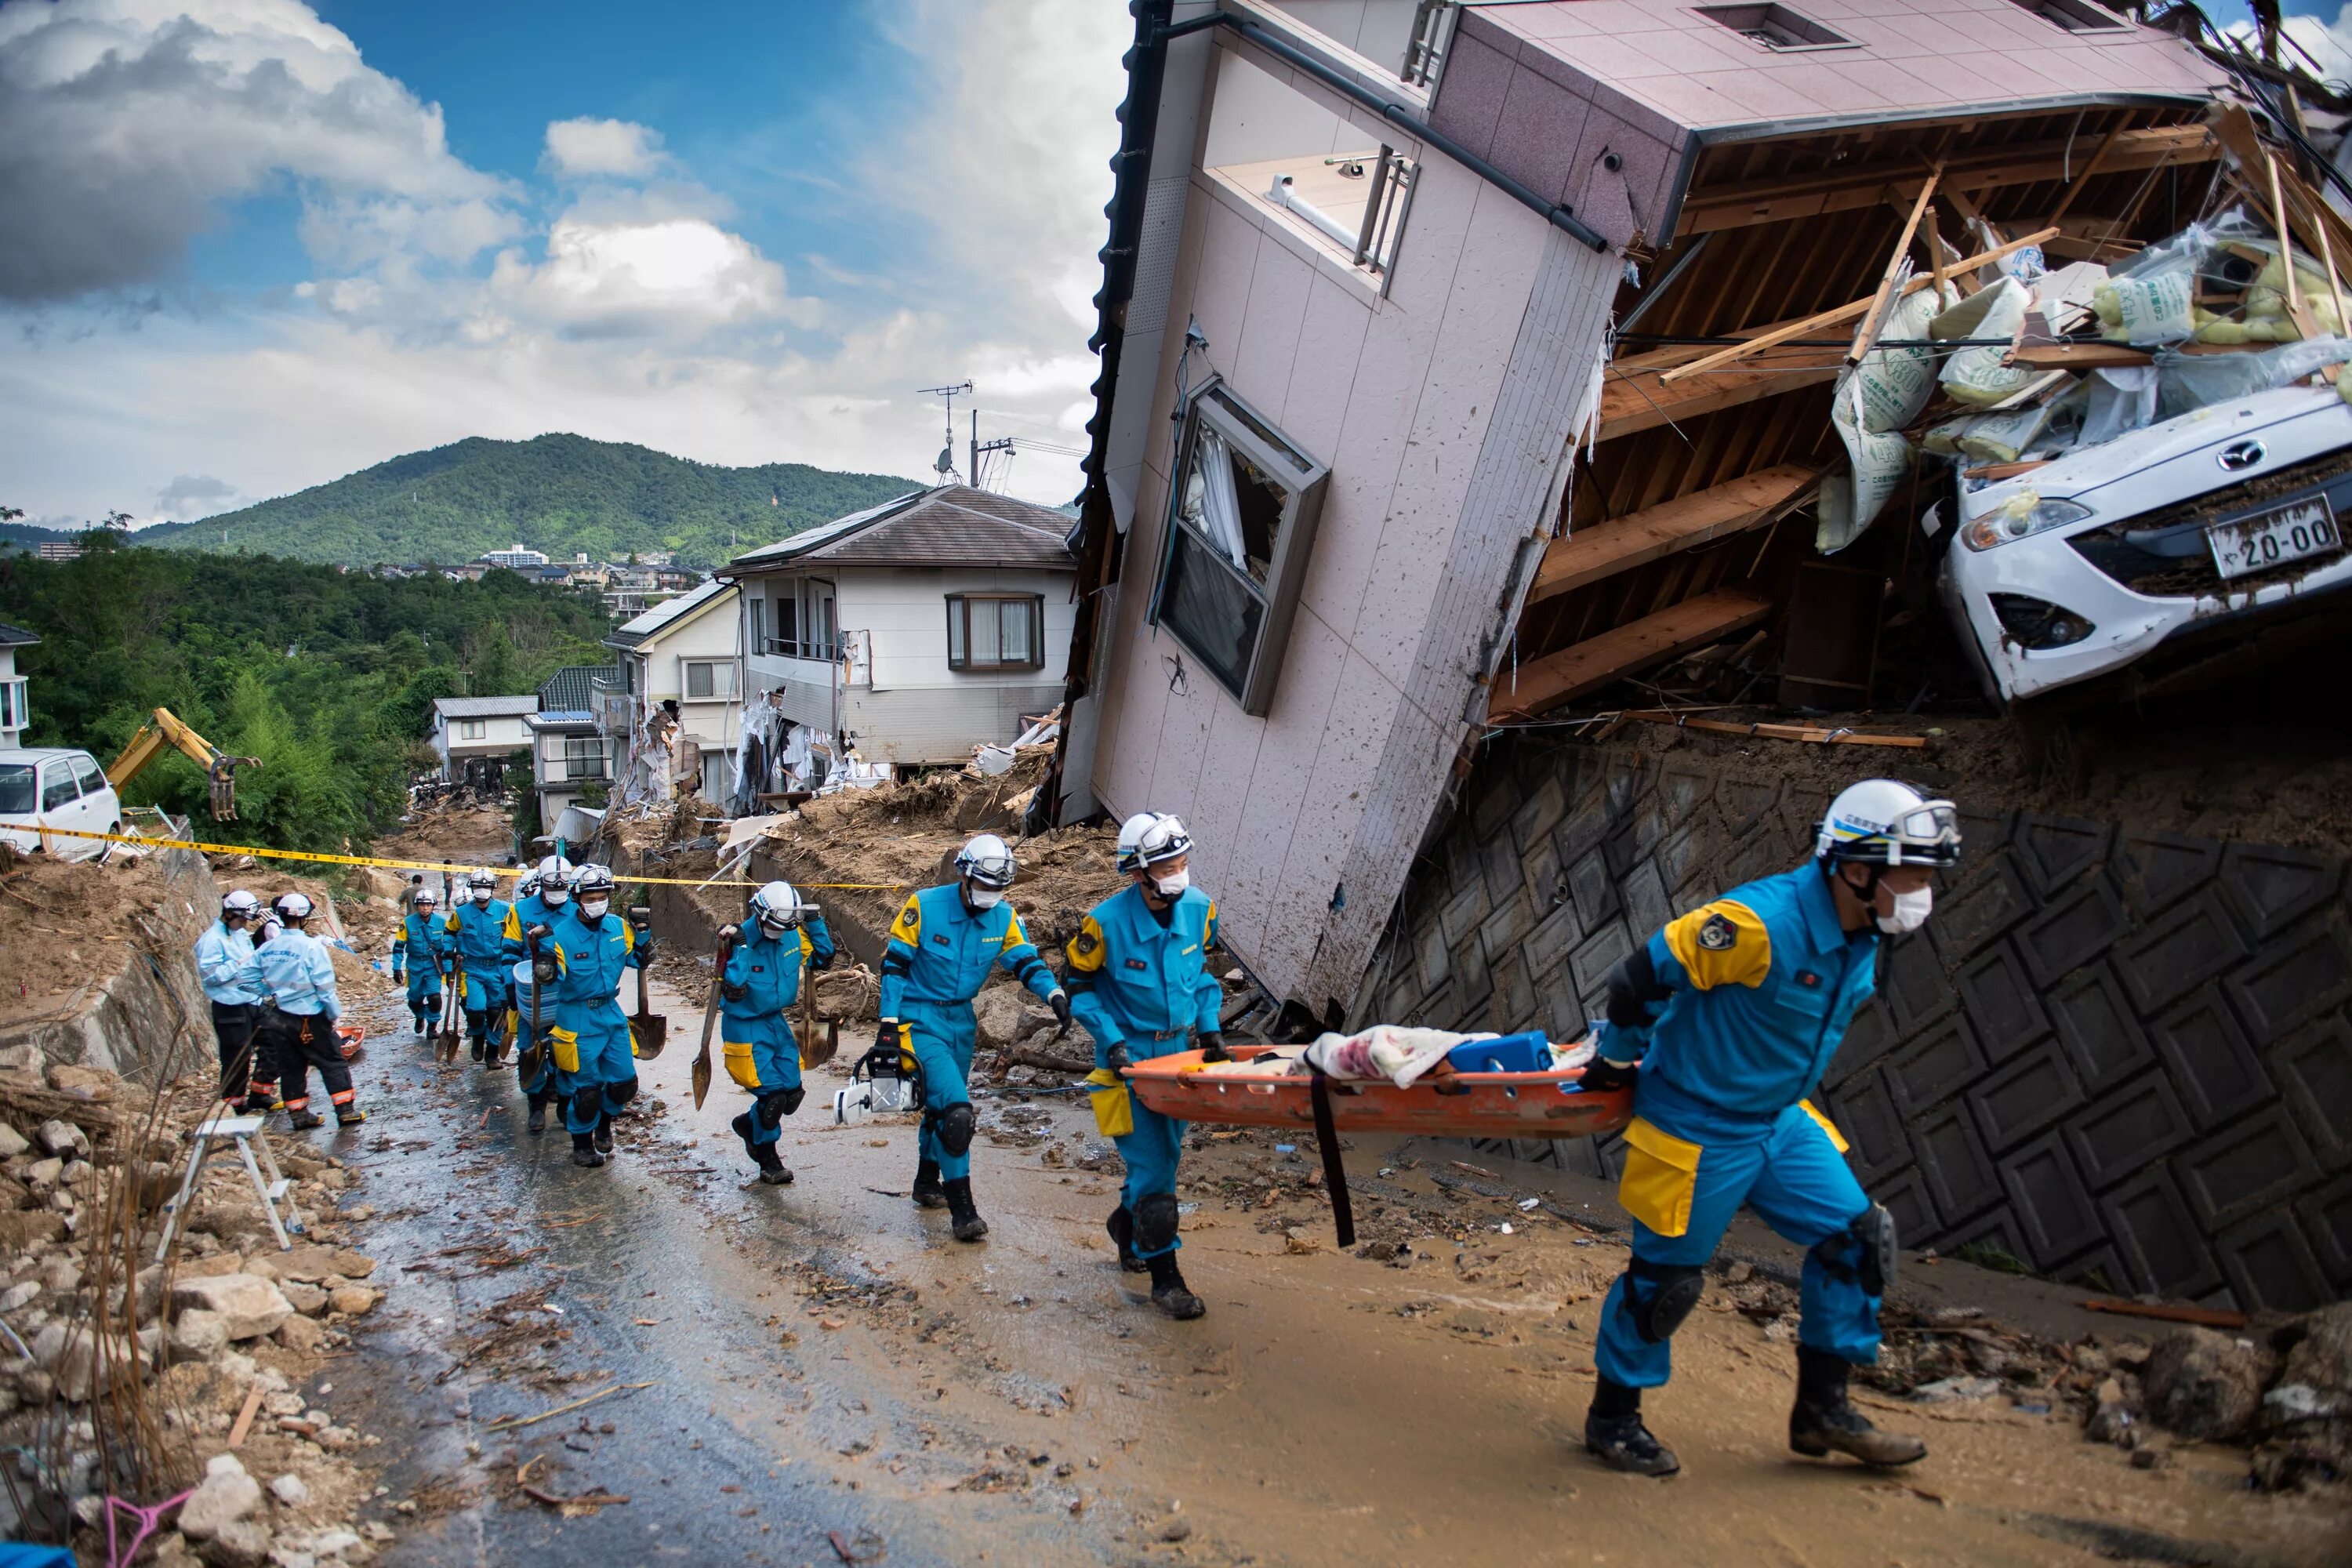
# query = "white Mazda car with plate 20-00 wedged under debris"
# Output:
<box><xmin>1940</xmin><ymin>386</ymin><xmax>2352</xmax><ymax>706</ymax></box>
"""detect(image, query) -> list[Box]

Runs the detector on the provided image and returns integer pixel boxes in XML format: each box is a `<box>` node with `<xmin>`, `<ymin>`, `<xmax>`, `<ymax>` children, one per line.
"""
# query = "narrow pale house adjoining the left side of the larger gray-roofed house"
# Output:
<box><xmin>595</xmin><ymin>581</ymin><xmax>743</xmax><ymax>801</ymax></box>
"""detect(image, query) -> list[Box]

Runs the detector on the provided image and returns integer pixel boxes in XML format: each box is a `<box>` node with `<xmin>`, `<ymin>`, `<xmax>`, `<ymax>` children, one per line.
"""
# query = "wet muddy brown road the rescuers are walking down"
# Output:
<box><xmin>310</xmin><ymin>940</ymin><xmax>2347</xmax><ymax>1568</ymax></box>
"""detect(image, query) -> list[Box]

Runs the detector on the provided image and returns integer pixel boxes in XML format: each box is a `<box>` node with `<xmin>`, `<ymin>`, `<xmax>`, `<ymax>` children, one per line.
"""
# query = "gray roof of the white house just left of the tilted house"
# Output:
<box><xmin>727</xmin><ymin>485</ymin><xmax>1077</xmax><ymax>572</ymax></box>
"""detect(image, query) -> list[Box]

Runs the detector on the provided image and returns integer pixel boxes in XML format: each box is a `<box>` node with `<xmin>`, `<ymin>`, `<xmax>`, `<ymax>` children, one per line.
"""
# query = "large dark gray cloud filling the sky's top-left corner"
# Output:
<box><xmin>0</xmin><ymin>0</ymin><xmax>515</xmax><ymax>301</ymax></box>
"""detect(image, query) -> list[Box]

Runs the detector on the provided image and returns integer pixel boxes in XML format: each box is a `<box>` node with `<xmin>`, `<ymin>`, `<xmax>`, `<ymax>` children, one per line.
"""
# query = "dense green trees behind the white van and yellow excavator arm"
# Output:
<box><xmin>0</xmin><ymin>543</ymin><xmax>612</xmax><ymax>851</ymax></box>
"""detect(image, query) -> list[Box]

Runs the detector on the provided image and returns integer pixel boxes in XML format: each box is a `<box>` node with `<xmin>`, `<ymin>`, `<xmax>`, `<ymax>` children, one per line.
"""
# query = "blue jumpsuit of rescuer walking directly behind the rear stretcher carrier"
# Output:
<box><xmin>882</xmin><ymin>881</ymin><xmax>1061</xmax><ymax>1182</ymax></box>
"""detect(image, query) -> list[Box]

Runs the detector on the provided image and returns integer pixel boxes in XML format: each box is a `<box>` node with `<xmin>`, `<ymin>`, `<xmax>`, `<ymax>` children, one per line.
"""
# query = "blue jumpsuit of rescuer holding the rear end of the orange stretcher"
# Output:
<box><xmin>1070</xmin><ymin>886</ymin><xmax>1225</xmax><ymax>1258</ymax></box>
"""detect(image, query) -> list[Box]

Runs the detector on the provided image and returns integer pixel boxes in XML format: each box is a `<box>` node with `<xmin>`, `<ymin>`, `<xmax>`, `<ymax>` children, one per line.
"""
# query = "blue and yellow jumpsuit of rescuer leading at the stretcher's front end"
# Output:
<box><xmin>1595</xmin><ymin>862</ymin><xmax>1879</xmax><ymax>1389</ymax></box>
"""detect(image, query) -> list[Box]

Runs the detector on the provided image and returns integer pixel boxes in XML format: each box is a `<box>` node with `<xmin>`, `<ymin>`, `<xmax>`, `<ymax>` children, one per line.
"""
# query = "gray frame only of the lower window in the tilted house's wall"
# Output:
<box><xmin>1148</xmin><ymin>376</ymin><xmax>1331</xmax><ymax>720</ymax></box>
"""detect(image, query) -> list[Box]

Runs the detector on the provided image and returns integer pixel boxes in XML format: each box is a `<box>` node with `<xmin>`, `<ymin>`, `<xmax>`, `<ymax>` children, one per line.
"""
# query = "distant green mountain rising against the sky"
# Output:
<box><xmin>139</xmin><ymin>435</ymin><xmax>917</xmax><ymax>567</ymax></box>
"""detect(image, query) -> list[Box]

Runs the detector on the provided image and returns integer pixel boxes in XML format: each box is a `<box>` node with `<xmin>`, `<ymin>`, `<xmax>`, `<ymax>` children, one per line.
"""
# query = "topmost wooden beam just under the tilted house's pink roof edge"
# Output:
<box><xmin>1675</xmin><ymin>125</ymin><xmax>2218</xmax><ymax>235</ymax></box>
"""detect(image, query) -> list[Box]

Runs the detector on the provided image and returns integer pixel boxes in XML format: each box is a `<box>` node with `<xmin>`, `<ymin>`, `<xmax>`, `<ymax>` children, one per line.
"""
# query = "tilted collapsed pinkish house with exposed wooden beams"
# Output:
<box><xmin>1054</xmin><ymin>0</ymin><xmax>2218</xmax><ymax>1020</ymax></box>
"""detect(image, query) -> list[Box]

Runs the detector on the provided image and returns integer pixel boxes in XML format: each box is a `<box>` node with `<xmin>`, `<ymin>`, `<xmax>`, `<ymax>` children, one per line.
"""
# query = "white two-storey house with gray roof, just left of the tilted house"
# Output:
<box><xmin>720</xmin><ymin>485</ymin><xmax>1075</xmax><ymax>767</ymax></box>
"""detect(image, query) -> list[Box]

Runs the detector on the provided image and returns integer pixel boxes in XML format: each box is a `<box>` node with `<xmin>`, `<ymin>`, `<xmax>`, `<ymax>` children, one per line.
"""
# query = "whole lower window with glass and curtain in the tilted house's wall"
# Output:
<box><xmin>1152</xmin><ymin>383</ymin><xmax>1331</xmax><ymax>715</ymax></box>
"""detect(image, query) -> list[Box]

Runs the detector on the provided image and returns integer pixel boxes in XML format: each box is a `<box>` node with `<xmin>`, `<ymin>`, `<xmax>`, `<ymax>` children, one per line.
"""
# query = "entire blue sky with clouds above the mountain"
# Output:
<box><xmin>0</xmin><ymin>0</ymin><xmax>1129</xmax><ymax>522</ymax></box>
